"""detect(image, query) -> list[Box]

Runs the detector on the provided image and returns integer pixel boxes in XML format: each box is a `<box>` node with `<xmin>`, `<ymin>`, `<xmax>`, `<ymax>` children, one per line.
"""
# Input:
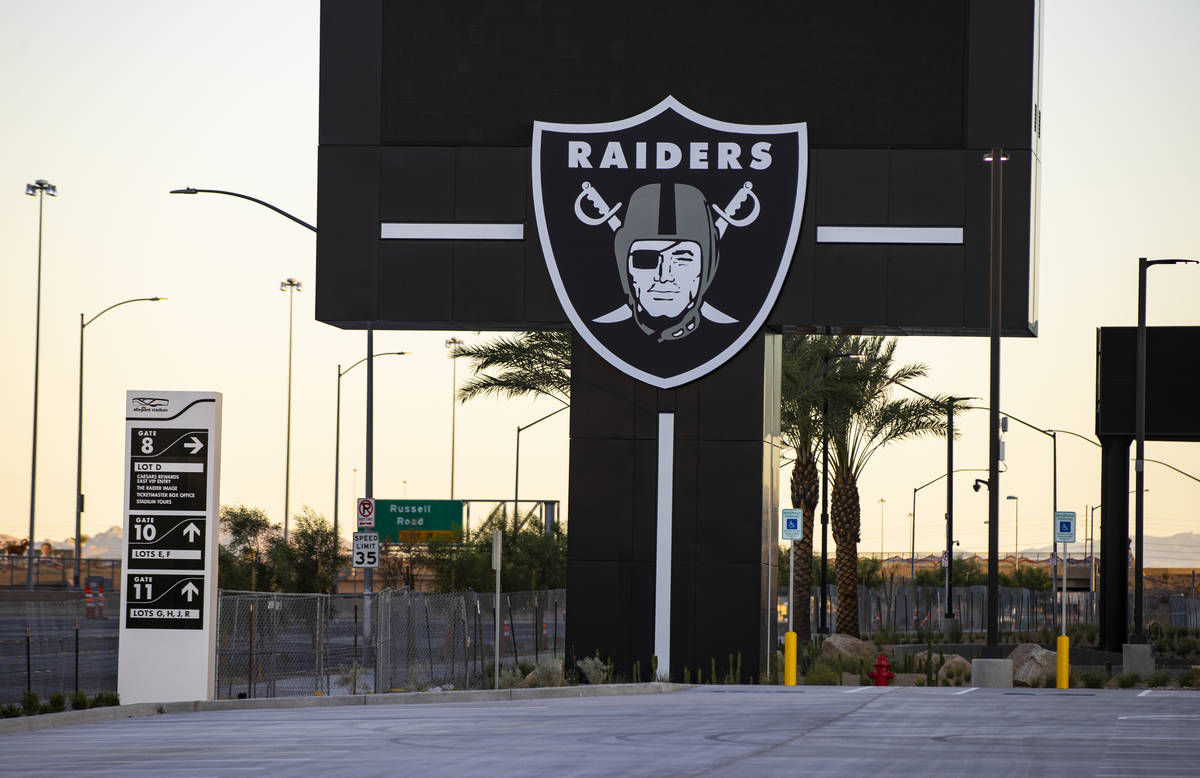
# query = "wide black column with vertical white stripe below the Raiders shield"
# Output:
<box><xmin>566</xmin><ymin>335</ymin><xmax>780</xmax><ymax>681</ymax></box>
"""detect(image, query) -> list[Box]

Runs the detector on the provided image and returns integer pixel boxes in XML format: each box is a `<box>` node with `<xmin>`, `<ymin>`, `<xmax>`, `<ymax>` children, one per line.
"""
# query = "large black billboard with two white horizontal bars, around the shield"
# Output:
<box><xmin>317</xmin><ymin>0</ymin><xmax>1040</xmax><ymax>335</ymax></box>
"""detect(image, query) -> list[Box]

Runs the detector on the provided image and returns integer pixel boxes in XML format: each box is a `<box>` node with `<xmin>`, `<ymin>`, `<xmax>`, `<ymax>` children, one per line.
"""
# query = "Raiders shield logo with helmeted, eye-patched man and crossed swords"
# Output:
<box><xmin>533</xmin><ymin>97</ymin><xmax>808</xmax><ymax>389</ymax></box>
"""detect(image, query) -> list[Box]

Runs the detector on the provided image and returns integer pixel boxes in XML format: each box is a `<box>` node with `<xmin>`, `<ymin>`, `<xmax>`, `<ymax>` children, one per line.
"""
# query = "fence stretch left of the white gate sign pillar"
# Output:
<box><xmin>0</xmin><ymin>597</ymin><xmax>120</xmax><ymax>705</ymax></box>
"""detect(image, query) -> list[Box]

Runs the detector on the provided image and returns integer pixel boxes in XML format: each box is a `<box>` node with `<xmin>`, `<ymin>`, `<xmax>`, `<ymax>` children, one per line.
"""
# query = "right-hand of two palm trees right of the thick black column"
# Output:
<box><xmin>828</xmin><ymin>337</ymin><xmax>948</xmax><ymax>638</ymax></box>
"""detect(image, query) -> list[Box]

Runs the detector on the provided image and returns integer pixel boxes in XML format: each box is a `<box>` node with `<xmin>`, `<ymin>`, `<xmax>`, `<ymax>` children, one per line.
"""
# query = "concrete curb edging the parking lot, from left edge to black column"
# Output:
<box><xmin>0</xmin><ymin>683</ymin><xmax>695</xmax><ymax>735</ymax></box>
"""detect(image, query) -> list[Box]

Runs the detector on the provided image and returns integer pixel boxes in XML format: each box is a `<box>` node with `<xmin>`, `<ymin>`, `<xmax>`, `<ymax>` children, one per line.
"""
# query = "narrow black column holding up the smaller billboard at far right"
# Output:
<box><xmin>1099</xmin><ymin>435</ymin><xmax>1133</xmax><ymax>652</ymax></box>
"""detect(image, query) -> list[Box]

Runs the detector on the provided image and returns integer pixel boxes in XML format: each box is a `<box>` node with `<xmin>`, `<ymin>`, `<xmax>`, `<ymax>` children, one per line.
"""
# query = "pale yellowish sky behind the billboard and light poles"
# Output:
<box><xmin>0</xmin><ymin>0</ymin><xmax>1200</xmax><ymax>562</ymax></box>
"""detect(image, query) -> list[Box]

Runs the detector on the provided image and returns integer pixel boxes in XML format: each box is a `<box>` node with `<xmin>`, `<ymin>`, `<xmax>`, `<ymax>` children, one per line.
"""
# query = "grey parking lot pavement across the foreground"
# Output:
<box><xmin>0</xmin><ymin>686</ymin><xmax>1200</xmax><ymax>778</ymax></box>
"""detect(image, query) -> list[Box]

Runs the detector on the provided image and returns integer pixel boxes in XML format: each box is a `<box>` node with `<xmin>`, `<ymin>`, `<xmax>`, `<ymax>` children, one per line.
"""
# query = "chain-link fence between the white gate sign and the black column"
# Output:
<box><xmin>217</xmin><ymin>590</ymin><xmax>566</xmax><ymax>699</ymax></box>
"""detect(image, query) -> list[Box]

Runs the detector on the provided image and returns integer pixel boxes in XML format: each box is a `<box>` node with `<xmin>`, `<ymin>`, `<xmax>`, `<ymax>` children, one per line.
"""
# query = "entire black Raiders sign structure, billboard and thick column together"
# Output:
<box><xmin>316</xmin><ymin>0</ymin><xmax>1040</xmax><ymax>678</ymax></box>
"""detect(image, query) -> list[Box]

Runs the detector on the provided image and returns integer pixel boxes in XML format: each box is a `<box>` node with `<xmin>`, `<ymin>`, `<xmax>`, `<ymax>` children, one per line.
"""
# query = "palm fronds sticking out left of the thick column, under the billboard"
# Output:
<box><xmin>450</xmin><ymin>331</ymin><xmax>571</xmax><ymax>406</ymax></box>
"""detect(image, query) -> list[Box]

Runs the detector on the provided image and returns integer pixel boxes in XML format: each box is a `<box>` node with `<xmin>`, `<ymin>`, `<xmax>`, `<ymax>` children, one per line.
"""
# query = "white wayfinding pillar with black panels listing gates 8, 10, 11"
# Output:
<box><xmin>116</xmin><ymin>391</ymin><xmax>221</xmax><ymax>702</ymax></box>
